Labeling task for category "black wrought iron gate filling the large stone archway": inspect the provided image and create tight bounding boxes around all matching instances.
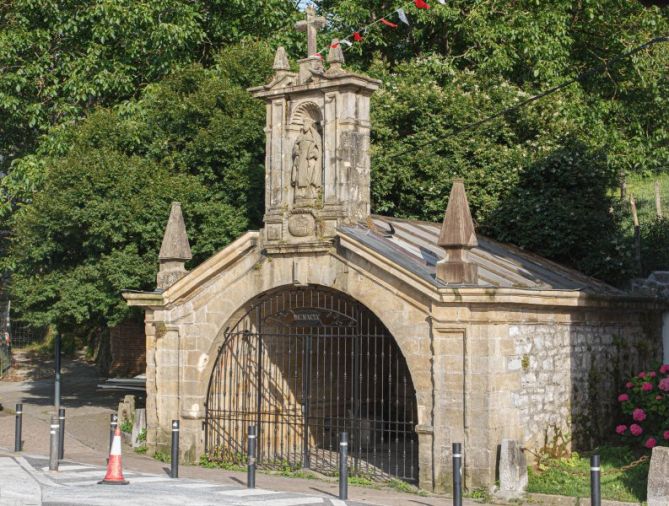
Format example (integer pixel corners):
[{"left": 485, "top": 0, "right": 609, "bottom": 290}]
[{"left": 205, "top": 288, "right": 418, "bottom": 482}]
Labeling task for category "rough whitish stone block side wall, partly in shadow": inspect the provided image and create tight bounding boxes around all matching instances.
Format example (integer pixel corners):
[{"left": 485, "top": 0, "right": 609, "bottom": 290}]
[{"left": 505, "top": 313, "right": 661, "bottom": 449}]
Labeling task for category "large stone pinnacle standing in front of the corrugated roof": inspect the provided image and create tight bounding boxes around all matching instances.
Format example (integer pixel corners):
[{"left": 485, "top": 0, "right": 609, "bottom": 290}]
[{"left": 437, "top": 178, "right": 478, "bottom": 284}]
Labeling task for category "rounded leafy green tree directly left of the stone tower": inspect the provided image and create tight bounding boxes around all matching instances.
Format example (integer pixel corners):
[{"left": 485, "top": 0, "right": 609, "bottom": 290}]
[{"left": 3, "top": 44, "right": 272, "bottom": 331}]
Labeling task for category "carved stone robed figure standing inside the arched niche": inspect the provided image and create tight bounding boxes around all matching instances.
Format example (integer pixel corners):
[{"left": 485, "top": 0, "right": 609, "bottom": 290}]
[{"left": 291, "top": 118, "right": 323, "bottom": 201}]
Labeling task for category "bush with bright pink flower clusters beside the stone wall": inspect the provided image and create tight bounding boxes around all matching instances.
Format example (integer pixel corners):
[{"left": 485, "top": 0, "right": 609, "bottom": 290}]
[{"left": 615, "top": 364, "right": 669, "bottom": 449}]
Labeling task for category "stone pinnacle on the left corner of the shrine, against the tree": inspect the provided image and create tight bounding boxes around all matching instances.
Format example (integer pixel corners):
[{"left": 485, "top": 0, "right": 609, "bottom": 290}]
[{"left": 157, "top": 202, "right": 193, "bottom": 290}]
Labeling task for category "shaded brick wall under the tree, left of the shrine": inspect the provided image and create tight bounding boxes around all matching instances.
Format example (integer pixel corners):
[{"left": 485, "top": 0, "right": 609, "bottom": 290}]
[{"left": 109, "top": 321, "right": 146, "bottom": 376}]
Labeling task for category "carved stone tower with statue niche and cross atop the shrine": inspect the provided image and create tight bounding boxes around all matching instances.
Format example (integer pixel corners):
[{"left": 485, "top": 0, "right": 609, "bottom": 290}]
[{"left": 249, "top": 6, "right": 380, "bottom": 252}]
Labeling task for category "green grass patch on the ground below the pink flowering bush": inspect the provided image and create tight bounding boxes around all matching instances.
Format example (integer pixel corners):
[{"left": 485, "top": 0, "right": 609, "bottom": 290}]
[{"left": 527, "top": 446, "right": 649, "bottom": 502}]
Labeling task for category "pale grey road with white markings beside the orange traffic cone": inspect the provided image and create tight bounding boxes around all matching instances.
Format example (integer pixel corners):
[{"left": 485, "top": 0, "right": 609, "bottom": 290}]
[{"left": 0, "top": 455, "right": 361, "bottom": 506}]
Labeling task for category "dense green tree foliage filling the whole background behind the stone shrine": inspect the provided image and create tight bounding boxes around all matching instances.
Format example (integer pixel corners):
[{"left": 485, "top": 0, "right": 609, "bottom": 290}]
[{"left": 0, "top": 0, "right": 669, "bottom": 327}]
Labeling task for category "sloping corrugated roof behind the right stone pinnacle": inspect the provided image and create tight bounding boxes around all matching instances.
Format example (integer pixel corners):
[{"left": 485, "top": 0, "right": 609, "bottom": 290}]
[{"left": 339, "top": 216, "right": 624, "bottom": 295}]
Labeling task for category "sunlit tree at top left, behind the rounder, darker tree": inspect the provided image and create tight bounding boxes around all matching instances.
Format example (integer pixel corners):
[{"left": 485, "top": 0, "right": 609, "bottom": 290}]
[{"left": 0, "top": 0, "right": 298, "bottom": 204}]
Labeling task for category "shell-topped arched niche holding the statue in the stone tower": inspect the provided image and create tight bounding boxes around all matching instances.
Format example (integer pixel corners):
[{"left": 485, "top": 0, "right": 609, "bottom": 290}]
[{"left": 290, "top": 102, "right": 324, "bottom": 207}]
